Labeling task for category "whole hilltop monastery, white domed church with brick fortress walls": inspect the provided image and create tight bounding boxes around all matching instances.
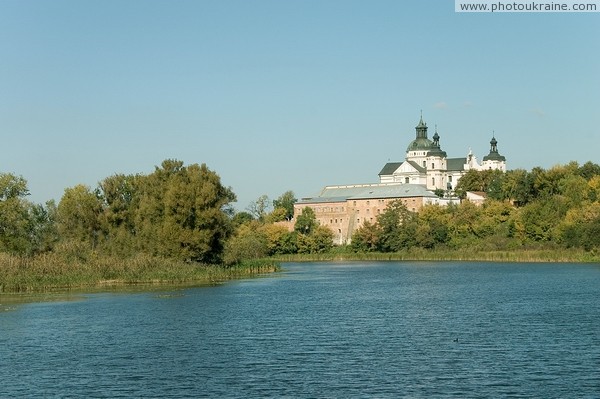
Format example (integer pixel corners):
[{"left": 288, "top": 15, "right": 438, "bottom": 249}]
[{"left": 294, "top": 112, "right": 506, "bottom": 244}]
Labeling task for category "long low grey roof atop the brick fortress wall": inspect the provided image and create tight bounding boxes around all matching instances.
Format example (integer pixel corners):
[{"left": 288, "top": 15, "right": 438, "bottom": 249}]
[{"left": 299, "top": 183, "right": 436, "bottom": 203}]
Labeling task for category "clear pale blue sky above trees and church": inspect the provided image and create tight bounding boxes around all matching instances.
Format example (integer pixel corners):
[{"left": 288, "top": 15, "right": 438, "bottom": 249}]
[{"left": 0, "top": 0, "right": 600, "bottom": 210}]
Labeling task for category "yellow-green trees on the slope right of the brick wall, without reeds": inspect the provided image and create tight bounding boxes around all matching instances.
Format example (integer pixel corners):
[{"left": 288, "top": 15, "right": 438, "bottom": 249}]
[{"left": 352, "top": 162, "right": 600, "bottom": 252}]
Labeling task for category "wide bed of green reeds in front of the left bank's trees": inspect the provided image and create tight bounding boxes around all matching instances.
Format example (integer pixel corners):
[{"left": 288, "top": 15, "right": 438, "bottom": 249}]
[{"left": 0, "top": 252, "right": 279, "bottom": 293}]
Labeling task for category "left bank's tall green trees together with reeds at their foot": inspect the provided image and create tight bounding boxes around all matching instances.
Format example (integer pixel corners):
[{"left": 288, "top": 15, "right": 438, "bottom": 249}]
[{"left": 0, "top": 160, "right": 277, "bottom": 292}]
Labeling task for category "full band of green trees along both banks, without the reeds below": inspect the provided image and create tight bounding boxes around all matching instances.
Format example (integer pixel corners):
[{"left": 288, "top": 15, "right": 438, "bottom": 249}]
[{"left": 0, "top": 160, "right": 600, "bottom": 265}]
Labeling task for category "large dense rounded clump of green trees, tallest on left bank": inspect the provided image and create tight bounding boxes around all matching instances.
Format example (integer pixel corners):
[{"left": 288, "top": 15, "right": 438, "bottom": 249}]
[{"left": 57, "top": 160, "right": 235, "bottom": 263}]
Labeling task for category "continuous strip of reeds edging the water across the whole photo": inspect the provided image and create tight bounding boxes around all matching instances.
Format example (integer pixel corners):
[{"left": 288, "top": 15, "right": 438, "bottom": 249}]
[{"left": 0, "top": 249, "right": 600, "bottom": 298}]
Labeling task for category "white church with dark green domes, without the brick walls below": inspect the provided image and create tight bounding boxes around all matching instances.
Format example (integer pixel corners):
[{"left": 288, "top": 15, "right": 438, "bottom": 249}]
[{"left": 379, "top": 115, "right": 506, "bottom": 190}]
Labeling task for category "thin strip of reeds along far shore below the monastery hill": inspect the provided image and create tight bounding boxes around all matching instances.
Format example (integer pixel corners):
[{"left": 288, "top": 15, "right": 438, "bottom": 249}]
[{"left": 273, "top": 248, "right": 600, "bottom": 262}]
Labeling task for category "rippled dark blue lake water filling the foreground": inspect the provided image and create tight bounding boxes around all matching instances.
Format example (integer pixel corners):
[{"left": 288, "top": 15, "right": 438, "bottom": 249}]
[{"left": 0, "top": 262, "right": 600, "bottom": 398}]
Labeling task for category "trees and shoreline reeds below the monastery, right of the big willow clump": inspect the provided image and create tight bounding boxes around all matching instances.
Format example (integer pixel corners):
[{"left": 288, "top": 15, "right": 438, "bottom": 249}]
[{"left": 230, "top": 162, "right": 600, "bottom": 262}]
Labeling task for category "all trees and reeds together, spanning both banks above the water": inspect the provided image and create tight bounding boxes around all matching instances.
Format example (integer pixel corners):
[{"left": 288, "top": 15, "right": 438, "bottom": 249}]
[{"left": 0, "top": 160, "right": 600, "bottom": 292}]
